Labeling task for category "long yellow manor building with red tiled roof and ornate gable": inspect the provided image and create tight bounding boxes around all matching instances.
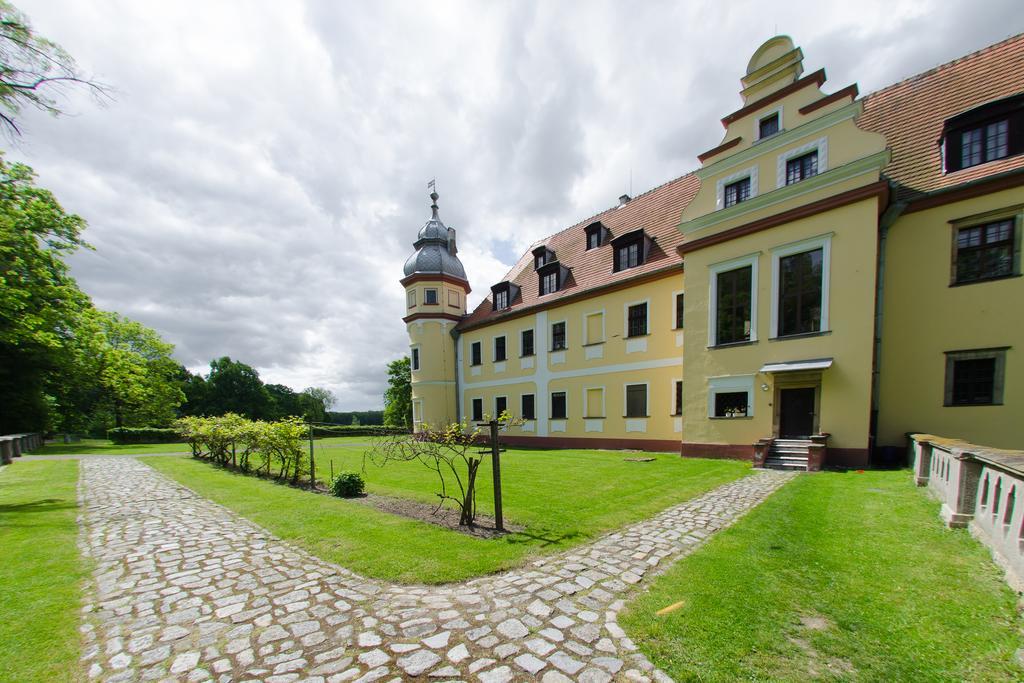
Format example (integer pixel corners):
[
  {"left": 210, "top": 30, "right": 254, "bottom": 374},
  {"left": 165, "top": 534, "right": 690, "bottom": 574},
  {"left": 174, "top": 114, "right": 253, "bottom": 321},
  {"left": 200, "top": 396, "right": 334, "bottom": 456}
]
[{"left": 402, "top": 36, "right": 1024, "bottom": 469}]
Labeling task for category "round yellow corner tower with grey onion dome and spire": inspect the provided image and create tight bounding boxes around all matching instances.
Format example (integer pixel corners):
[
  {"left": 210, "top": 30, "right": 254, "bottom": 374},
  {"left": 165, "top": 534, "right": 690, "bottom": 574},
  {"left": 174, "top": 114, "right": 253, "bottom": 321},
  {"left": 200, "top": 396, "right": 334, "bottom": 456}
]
[{"left": 401, "top": 191, "right": 470, "bottom": 431}]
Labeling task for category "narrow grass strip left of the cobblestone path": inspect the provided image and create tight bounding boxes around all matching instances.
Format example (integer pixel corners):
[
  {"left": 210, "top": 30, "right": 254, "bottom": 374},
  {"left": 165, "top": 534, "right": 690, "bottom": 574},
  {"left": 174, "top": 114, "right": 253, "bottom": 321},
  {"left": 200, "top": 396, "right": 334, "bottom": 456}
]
[{"left": 0, "top": 461, "right": 87, "bottom": 681}]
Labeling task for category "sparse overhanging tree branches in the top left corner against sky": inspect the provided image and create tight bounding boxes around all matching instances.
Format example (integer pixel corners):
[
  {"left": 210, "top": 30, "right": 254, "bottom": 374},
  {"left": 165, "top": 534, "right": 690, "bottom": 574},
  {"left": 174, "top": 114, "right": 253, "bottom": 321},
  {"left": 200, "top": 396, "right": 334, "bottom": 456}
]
[{"left": 0, "top": 0, "right": 110, "bottom": 136}]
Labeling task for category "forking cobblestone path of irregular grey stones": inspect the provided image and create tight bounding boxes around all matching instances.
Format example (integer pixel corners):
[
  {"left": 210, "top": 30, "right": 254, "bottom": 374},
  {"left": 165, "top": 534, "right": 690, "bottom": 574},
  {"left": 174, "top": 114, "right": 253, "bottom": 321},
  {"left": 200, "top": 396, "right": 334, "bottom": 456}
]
[{"left": 79, "top": 458, "right": 794, "bottom": 683}]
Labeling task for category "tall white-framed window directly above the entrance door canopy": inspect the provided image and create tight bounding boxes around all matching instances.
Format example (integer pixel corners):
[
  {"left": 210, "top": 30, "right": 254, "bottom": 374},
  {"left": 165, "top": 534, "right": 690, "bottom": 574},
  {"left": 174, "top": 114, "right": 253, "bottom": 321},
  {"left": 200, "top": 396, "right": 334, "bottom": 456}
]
[{"left": 778, "top": 249, "right": 823, "bottom": 337}]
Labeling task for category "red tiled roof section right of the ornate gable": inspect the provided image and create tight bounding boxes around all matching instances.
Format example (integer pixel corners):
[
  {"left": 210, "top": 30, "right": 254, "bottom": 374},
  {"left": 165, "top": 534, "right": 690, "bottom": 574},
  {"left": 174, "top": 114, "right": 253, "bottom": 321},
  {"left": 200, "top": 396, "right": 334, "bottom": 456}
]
[{"left": 857, "top": 34, "right": 1024, "bottom": 200}]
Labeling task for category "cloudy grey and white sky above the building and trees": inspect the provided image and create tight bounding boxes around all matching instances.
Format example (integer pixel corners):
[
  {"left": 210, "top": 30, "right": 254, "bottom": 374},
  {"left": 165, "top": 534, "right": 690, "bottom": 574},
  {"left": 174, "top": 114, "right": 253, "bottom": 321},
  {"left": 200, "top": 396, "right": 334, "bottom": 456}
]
[{"left": 6, "top": 0, "right": 1024, "bottom": 410}]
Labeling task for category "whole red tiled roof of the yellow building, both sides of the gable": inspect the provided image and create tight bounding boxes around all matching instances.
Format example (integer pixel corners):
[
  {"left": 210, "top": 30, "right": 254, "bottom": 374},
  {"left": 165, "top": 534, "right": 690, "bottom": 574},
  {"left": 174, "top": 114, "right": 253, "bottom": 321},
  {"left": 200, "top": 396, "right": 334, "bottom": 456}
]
[{"left": 458, "top": 34, "right": 1024, "bottom": 330}]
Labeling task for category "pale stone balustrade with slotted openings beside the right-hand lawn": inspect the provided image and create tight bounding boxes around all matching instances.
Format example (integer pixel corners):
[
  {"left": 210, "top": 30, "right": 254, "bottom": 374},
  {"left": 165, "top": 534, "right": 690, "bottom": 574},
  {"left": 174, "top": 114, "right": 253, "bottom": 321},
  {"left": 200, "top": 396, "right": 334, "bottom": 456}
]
[{"left": 909, "top": 434, "right": 1024, "bottom": 592}]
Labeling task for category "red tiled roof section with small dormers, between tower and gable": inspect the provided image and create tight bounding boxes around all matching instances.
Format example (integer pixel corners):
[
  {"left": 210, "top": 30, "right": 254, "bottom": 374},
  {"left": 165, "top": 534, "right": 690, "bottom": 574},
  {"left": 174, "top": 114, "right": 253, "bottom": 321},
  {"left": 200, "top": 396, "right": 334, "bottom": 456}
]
[{"left": 459, "top": 173, "right": 700, "bottom": 330}]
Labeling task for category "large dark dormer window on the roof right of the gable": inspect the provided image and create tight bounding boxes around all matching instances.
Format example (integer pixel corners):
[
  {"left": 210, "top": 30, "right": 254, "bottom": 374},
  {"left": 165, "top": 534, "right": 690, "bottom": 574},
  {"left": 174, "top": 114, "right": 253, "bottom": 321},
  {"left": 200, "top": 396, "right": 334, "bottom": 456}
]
[{"left": 942, "top": 94, "right": 1024, "bottom": 173}]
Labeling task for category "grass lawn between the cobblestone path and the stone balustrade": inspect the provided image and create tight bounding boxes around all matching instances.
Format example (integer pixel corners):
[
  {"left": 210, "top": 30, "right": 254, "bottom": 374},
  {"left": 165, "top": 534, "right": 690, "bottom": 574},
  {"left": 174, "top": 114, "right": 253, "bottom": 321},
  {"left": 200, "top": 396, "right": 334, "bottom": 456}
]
[{"left": 621, "top": 471, "right": 1024, "bottom": 681}]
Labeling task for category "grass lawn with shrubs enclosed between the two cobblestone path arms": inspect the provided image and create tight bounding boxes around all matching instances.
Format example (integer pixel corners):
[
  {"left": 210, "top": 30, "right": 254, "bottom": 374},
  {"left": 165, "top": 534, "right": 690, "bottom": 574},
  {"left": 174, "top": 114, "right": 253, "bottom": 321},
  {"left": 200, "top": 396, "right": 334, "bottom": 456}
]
[{"left": 144, "top": 446, "right": 750, "bottom": 584}]
